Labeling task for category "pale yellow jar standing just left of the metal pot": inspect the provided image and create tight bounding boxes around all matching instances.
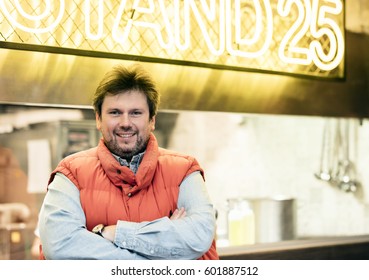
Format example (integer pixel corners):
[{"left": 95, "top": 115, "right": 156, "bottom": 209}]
[{"left": 227, "top": 198, "right": 255, "bottom": 246}]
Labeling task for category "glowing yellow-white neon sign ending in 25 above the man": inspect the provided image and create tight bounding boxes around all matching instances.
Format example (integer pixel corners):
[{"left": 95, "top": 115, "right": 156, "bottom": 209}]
[{"left": 0, "top": 0, "right": 345, "bottom": 78}]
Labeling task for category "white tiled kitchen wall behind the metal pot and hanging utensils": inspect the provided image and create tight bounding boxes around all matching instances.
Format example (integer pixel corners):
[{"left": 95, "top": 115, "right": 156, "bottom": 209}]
[{"left": 165, "top": 112, "right": 369, "bottom": 236}]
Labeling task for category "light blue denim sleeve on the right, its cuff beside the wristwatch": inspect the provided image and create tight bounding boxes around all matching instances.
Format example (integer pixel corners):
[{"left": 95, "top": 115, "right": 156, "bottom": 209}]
[{"left": 114, "top": 172, "right": 215, "bottom": 259}]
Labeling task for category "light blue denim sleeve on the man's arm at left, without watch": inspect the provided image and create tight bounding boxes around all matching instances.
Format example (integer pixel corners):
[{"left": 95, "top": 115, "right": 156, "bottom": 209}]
[{"left": 38, "top": 173, "right": 147, "bottom": 260}]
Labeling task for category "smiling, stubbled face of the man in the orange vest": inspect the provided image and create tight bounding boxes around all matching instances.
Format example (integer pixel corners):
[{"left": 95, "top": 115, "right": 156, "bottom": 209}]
[{"left": 96, "top": 90, "right": 155, "bottom": 159}]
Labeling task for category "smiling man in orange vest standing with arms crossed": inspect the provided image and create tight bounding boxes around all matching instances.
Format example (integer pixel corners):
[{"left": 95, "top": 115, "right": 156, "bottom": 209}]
[{"left": 39, "top": 66, "right": 218, "bottom": 259}]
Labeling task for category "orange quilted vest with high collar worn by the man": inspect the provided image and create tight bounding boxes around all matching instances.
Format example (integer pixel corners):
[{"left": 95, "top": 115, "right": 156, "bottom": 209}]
[{"left": 50, "top": 134, "right": 219, "bottom": 259}]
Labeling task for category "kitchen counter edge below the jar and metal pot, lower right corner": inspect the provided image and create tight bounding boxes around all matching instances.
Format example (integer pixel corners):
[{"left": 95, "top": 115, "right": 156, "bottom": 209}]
[{"left": 218, "top": 235, "right": 369, "bottom": 260}]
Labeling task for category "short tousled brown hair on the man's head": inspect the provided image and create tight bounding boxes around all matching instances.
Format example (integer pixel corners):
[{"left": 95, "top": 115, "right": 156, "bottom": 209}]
[{"left": 93, "top": 64, "right": 160, "bottom": 119}]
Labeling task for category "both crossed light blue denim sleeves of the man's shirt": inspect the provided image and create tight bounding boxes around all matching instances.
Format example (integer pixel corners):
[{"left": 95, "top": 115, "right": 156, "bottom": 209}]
[{"left": 39, "top": 172, "right": 215, "bottom": 260}]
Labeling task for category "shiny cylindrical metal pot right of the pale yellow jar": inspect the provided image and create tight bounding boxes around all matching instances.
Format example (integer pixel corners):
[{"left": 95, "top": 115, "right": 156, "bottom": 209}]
[{"left": 251, "top": 197, "right": 296, "bottom": 243}]
